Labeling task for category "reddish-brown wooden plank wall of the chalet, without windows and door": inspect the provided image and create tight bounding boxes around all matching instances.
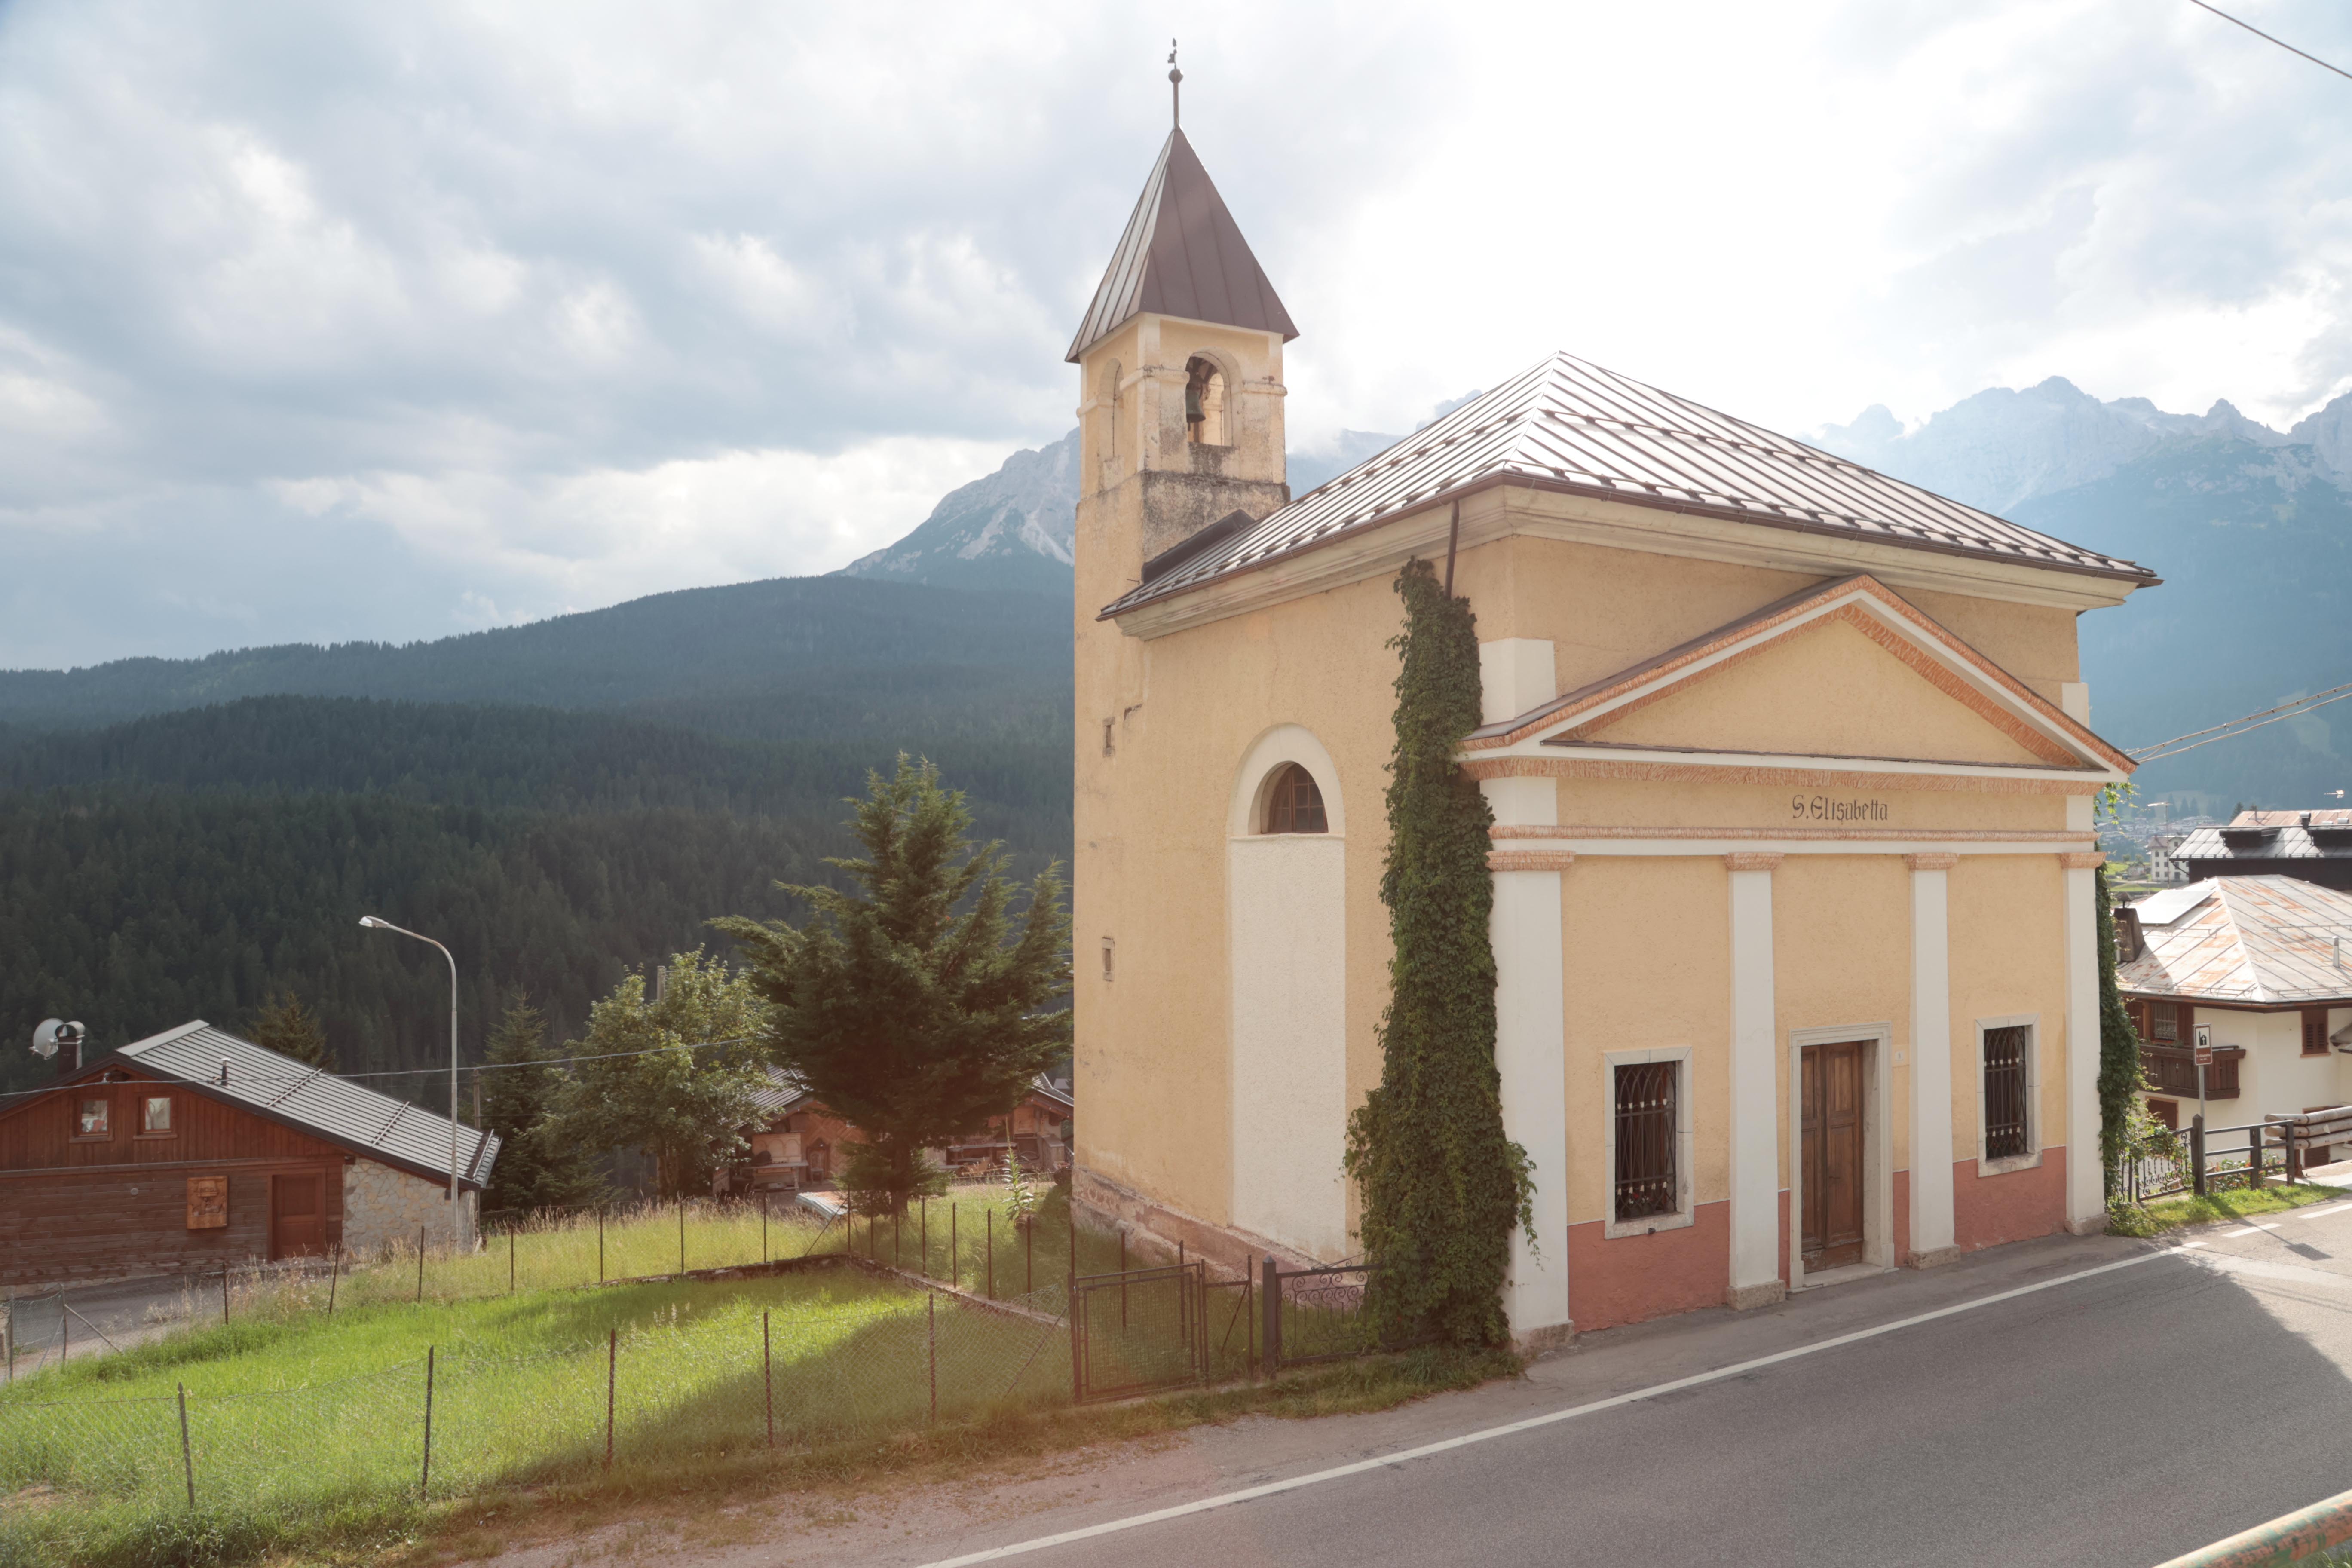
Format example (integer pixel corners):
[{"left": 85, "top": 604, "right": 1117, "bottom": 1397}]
[{"left": 0, "top": 1077, "right": 346, "bottom": 1283}]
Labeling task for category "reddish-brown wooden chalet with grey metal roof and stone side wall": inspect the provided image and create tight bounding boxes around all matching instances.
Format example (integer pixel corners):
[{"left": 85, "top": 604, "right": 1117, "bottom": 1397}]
[{"left": 0, "top": 1020, "right": 499, "bottom": 1283}]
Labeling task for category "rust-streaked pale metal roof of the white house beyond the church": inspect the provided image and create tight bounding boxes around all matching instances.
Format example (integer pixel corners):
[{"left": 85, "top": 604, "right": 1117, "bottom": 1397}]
[{"left": 2114, "top": 877, "right": 2352, "bottom": 1006}]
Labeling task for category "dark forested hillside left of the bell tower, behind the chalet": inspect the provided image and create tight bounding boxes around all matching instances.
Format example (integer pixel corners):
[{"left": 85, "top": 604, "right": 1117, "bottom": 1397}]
[{"left": 0, "top": 578, "right": 1070, "bottom": 1098}]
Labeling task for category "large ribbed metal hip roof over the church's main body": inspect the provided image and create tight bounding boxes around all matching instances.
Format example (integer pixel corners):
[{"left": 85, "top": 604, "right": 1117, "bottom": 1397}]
[{"left": 1103, "top": 352, "right": 2157, "bottom": 616}]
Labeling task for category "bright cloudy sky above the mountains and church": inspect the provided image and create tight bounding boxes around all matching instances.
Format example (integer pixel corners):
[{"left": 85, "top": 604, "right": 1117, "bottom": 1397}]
[{"left": 0, "top": 0, "right": 2352, "bottom": 665}]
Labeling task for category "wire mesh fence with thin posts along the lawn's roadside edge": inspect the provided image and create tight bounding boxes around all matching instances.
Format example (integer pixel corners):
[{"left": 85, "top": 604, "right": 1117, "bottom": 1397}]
[{"left": 0, "top": 1286, "right": 1070, "bottom": 1528}]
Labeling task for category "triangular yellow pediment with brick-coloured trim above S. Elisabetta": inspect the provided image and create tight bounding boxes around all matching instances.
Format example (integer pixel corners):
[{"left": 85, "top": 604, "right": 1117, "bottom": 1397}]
[{"left": 1465, "top": 576, "right": 2133, "bottom": 778}]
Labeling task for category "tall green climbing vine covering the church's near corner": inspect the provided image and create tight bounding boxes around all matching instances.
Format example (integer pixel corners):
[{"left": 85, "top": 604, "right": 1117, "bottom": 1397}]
[{"left": 1348, "top": 560, "right": 1534, "bottom": 1344}]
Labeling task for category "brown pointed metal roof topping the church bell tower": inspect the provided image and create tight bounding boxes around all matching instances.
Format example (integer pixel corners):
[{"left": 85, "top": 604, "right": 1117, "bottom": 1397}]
[{"left": 1068, "top": 129, "right": 1298, "bottom": 364}]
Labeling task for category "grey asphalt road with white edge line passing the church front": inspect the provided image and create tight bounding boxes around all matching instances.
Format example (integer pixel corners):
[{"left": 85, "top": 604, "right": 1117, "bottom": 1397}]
[{"left": 868, "top": 1204, "right": 2352, "bottom": 1568}]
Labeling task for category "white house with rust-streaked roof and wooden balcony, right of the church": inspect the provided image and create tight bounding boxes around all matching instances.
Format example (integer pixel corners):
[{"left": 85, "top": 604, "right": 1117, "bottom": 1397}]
[{"left": 2114, "top": 875, "right": 2352, "bottom": 1159}]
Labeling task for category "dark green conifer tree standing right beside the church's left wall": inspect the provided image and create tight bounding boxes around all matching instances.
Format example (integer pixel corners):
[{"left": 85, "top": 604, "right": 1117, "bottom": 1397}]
[{"left": 713, "top": 755, "right": 1070, "bottom": 1211}]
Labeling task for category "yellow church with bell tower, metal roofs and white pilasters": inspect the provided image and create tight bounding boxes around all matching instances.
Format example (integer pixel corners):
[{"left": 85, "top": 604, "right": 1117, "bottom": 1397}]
[{"left": 1068, "top": 129, "right": 2157, "bottom": 1344}]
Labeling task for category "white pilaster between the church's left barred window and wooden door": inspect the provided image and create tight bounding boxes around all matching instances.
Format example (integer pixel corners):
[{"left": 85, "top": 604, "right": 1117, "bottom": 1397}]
[{"left": 1724, "top": 853, "right": 1785, "bottom": 1307}]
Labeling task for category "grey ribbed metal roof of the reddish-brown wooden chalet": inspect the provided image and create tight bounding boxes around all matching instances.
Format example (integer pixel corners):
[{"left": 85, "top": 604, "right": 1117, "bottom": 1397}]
[{"left": 103, "top": 1018, "right": 499, "bottom": 1187}]
